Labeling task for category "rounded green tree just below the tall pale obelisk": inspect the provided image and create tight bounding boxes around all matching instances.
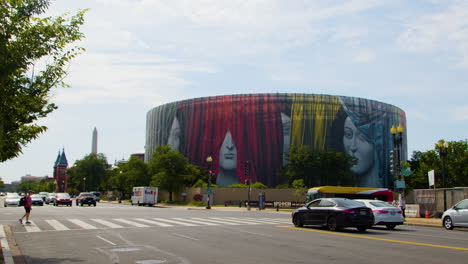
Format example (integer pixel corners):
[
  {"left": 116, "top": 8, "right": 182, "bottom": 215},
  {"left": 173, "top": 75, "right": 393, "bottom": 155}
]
[{"left": 67, "top": 153, "right": 109, "bottom": 193}]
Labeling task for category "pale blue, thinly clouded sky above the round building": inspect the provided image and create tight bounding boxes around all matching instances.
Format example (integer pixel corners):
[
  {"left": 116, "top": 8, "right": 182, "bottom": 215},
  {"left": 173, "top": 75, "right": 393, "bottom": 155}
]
[{"left": 0, "top": 0, "right": 468, "bottom": 183}]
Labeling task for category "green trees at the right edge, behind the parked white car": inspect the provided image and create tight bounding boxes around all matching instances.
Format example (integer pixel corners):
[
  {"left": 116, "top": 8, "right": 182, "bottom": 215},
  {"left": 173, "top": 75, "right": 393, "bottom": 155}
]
[{"left": 405, "top": 140, "right": 468, "bottom": 191}]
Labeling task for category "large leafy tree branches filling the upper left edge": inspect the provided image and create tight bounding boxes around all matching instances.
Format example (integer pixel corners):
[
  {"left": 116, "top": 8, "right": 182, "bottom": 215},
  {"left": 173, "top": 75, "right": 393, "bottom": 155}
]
[{"left": 0, "top": 0, "right": 86, "bottom": 162}]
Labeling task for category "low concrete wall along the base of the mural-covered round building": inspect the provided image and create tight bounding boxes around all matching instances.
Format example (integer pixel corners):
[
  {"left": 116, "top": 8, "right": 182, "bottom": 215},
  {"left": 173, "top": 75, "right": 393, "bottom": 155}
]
[{"left": 158, "top": 188, "right": 307, "bottom": 205}]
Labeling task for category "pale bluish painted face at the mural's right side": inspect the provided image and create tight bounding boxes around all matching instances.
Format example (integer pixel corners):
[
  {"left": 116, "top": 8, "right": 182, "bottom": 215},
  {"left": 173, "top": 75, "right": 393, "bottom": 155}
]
[{"left": 343, "top": 117, "right": 374, "bottom": 174}]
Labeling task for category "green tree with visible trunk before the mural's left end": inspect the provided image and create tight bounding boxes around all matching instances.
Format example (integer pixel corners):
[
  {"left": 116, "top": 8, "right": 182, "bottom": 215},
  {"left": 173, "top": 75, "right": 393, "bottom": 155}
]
[{"left": 149, "top": 145, "right": 188, "bottom": 201}]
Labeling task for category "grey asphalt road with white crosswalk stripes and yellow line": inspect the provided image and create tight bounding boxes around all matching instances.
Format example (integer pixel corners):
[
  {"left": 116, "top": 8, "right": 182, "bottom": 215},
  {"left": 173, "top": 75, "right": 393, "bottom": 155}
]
[{"left": 0, "top": 203, "right": 468, "bottom": 264}]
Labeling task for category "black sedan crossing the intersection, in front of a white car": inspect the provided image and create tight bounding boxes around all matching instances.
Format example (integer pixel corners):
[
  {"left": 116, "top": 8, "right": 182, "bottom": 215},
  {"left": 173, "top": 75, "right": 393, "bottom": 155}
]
[{"left": 292, "top": 198, "right": 374, "bottom": 232}]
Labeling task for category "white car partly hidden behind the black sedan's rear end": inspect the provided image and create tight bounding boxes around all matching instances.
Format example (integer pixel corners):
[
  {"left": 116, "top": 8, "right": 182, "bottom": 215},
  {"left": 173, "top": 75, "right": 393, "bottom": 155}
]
[{"left": 356, "top": 200, "right": 405, "bottom": 230}]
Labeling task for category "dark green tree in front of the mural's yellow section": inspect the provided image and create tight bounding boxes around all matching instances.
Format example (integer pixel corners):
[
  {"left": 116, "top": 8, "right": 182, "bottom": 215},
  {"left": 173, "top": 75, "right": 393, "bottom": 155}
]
[{"left": 283, "top": 146, "right": 356, "bottom": 187}]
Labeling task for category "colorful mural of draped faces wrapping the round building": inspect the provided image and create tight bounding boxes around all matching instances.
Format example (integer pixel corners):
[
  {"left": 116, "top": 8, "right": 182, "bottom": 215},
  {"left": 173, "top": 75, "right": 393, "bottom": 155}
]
[{"left": 145, "top": 94, "right": 406, "bottom": 188}]
